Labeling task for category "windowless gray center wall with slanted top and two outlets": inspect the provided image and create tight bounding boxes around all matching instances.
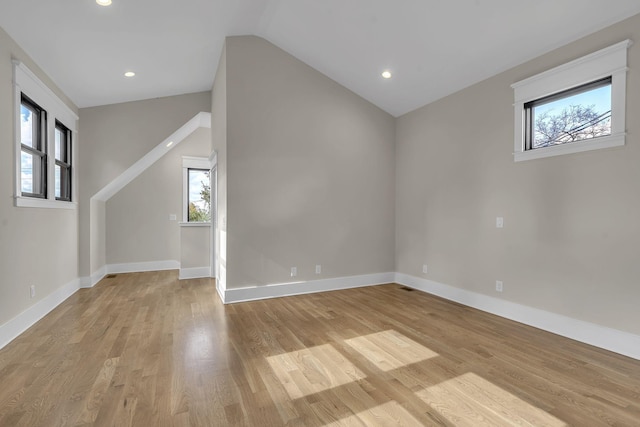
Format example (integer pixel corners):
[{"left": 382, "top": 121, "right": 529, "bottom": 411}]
[{"left": 226, "top": 36, "right": 395, "bottom": 288}]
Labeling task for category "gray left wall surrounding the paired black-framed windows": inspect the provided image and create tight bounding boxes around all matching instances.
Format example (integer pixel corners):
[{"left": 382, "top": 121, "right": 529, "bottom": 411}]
[{"left": 0, "top": 28, "right": 78, "bottom": 325}]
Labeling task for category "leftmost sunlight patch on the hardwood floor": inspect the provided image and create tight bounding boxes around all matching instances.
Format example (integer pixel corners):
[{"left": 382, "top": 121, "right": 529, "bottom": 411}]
[{"left": 267, "top": 344, "right": 365, "bottom": 399}]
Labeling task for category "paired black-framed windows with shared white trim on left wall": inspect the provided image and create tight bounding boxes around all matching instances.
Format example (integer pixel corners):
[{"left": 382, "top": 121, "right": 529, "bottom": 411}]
[{"left": 13, "top": 60, "right": 78, "bottom": 209}]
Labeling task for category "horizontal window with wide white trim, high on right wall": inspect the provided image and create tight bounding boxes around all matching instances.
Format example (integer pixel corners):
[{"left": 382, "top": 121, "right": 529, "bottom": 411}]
[{"left": 512, "top": 40, "right": 630, "bottom": 161}]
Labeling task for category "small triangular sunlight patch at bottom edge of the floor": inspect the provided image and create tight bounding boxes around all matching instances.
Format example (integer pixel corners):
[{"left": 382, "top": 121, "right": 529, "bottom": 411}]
[{"left": 325, "top": 400, "right": 423, "bottom": 427}]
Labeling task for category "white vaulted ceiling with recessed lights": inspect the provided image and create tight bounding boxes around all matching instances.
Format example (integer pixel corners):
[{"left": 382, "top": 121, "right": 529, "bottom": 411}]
[{"left": 0, "top": 0, "right": 640, "bottom": 116}]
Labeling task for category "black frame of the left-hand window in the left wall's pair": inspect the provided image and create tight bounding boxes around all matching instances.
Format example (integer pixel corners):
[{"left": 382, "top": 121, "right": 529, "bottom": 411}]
[{"left": 20, "top": 93, "right": 48, "bottom": 199}]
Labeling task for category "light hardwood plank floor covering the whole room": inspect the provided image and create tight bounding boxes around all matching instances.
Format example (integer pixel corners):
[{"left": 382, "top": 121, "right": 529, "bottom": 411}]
[{"left": 0, "top": 271, "right": 640, "bottom": 427}]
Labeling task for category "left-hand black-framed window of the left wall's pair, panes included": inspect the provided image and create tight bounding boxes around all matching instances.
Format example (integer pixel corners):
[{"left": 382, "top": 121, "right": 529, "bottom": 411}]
[{"left": 20, "top": 95, "right": 47, "bottom": 198}]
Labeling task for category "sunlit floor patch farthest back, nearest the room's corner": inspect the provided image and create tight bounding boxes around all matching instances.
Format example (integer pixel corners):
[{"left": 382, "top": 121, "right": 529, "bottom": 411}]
[{"left": 345, "top": 330, "right": 438, "bottom": 371}]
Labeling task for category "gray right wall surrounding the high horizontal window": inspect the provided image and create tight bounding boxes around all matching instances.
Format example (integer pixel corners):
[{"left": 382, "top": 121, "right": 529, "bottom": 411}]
[{"left": 396, "top": 15, "right": 640, "bottom": 334}]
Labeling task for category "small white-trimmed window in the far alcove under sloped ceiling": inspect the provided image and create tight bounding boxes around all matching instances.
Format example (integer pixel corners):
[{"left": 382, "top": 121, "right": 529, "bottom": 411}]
[{"left": 182, "top": 156, "right": 211, "bottom": 225}]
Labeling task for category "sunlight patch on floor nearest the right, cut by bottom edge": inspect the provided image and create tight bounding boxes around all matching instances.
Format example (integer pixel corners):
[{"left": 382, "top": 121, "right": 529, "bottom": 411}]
[{"left": 416, "top": 372, "right": 566, "bottom": 427}]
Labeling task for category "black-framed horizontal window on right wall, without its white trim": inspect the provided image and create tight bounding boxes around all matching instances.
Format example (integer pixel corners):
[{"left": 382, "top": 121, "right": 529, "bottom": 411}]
[{"left": 524, "top": 76, "right": 611, "bottom": 150}]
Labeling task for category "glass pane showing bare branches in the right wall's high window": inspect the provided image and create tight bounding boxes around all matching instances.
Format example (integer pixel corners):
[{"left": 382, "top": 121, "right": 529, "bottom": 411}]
[{"left": 531, "top": 83, "right": 611, "bottom": 148}]
